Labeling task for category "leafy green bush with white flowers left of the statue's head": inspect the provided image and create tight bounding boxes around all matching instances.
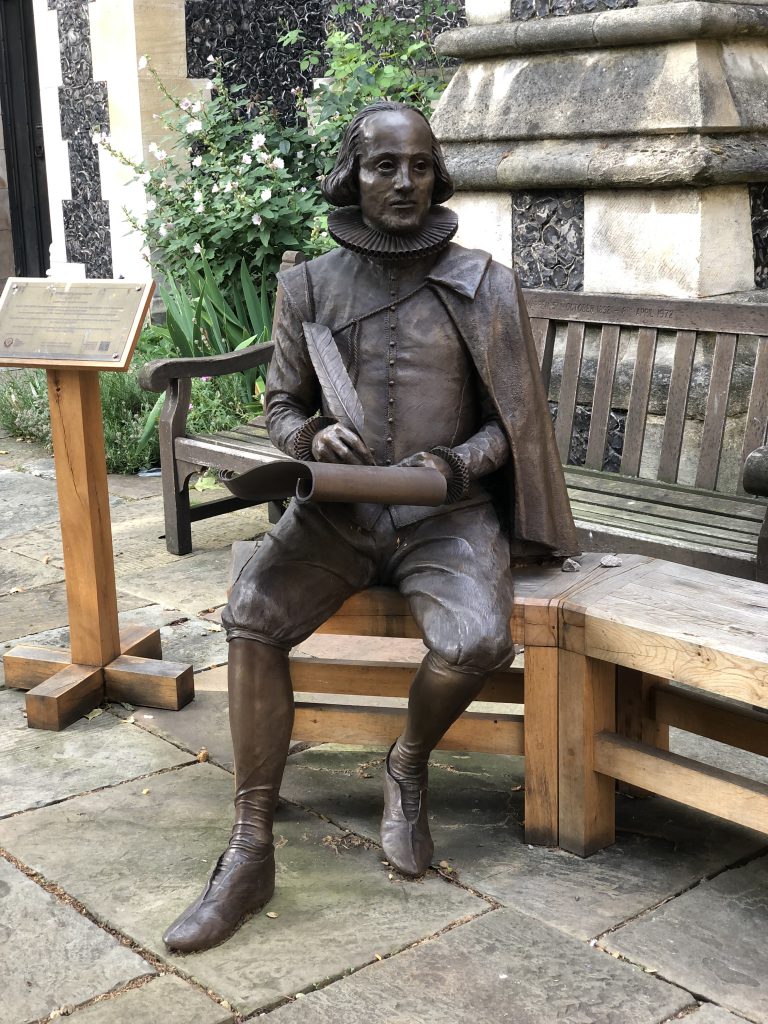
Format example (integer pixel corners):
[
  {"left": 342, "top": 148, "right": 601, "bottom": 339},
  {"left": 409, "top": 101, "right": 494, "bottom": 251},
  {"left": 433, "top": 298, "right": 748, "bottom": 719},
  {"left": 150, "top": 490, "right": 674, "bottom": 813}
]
[{"left": 94, "top": 57, "right": 327, "bottom": 285}]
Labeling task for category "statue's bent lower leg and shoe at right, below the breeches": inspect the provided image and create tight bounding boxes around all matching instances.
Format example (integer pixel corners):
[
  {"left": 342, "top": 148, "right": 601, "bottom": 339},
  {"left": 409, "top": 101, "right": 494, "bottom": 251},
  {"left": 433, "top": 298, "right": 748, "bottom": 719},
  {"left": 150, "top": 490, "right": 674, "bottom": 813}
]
[{"left": 381, "top": 651, "right": 487, "bottom": 878}]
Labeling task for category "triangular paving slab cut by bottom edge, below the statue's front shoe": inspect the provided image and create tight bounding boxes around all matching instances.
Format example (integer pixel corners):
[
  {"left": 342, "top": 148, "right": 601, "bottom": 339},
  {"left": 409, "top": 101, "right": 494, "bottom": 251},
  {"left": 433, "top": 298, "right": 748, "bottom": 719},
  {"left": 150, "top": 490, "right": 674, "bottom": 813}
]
[{"left": 62, "top": 974, "right": 233, "bottom": 1024}]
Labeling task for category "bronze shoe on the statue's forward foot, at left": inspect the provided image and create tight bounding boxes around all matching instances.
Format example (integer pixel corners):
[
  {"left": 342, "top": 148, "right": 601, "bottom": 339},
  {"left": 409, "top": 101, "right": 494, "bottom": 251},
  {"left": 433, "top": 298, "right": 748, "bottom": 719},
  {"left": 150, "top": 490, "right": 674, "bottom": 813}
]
[{"left": 163, "top": 847, "right": 274, "bottom": 953}]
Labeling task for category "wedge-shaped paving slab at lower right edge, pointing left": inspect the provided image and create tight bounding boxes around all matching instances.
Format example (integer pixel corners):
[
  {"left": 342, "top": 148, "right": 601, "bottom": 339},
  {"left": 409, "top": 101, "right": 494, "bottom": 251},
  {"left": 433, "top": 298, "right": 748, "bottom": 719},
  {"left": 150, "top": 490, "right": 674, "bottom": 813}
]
[{"left": 605, "top": 856, "right": 768, "bottom": 1024}]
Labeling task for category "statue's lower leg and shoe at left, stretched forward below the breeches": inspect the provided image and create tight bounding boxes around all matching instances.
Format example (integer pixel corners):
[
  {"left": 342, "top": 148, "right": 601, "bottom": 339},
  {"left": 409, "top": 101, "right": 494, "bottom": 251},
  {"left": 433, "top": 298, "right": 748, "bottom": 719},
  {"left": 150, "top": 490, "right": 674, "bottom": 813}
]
[{"left": 163, "top": 638, "right": 294, "bottom": 953}]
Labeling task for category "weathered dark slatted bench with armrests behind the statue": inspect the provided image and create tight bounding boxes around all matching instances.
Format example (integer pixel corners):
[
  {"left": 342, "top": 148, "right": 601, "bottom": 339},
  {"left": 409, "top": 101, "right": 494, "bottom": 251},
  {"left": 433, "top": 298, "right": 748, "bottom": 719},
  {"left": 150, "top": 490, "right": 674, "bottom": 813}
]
[{"left": 141, "top": 276, "right": 768, "bottom": 581}]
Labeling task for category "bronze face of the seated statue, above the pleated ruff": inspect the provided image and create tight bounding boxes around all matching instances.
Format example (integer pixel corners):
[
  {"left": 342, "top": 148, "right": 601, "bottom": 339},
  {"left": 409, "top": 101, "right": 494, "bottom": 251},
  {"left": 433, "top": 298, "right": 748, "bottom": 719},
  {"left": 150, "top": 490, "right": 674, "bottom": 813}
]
[{"left": 358, "top": 111, "right": 434, "bottom": 234}]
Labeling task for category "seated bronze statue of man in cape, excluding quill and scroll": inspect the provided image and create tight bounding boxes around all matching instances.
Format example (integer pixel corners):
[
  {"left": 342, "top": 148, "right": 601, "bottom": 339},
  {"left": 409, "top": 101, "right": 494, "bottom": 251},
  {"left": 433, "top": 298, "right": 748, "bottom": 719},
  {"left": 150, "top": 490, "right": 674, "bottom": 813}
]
[{"left": 164, "top": 101, "right": 578, "bottom": 952}]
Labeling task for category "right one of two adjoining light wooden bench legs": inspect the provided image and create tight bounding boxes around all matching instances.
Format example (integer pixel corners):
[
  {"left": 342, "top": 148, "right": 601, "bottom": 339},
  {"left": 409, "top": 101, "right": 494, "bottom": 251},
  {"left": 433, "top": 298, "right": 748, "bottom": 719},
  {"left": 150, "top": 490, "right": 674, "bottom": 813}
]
[{"left": 558, "top": 650, "right": 616, "bottom": 857}]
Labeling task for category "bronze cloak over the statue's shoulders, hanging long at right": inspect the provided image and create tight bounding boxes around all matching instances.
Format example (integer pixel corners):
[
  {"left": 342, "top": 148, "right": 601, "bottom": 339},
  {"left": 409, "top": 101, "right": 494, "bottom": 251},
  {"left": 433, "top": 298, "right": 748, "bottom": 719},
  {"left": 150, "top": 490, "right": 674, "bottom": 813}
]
[{"left": 281, "top": 244, "right": 580, "bottom": 559}]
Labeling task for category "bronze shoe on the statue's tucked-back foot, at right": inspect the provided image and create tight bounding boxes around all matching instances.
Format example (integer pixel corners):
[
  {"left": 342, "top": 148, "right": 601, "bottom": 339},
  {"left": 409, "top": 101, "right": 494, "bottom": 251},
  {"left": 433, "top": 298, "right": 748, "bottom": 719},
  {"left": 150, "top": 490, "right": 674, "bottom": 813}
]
[{"left": 381, "top": 748, "right": 434, "bottom": 878}]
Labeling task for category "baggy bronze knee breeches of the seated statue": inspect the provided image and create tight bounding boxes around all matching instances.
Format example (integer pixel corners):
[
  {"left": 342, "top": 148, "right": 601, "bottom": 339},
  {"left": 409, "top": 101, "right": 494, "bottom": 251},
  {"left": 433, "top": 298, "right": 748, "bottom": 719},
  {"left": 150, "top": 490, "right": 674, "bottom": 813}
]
[{"left": 221, "top": 502, "right": 513, "bottom": 673}]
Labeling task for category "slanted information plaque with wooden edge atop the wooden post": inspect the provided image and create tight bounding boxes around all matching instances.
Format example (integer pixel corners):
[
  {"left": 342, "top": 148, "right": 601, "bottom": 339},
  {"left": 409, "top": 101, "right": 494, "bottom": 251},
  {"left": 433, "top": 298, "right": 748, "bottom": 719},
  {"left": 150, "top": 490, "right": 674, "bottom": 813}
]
[{"left": 0, "top": 278, "right": 154, "bottom": 370}]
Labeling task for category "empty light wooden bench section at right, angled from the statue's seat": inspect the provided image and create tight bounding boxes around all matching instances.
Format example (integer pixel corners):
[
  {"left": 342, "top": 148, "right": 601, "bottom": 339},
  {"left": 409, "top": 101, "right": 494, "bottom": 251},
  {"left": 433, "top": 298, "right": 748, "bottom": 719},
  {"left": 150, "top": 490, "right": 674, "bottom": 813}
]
[{"left": 557, "top": 557, "right": 768, "bottom": 856}]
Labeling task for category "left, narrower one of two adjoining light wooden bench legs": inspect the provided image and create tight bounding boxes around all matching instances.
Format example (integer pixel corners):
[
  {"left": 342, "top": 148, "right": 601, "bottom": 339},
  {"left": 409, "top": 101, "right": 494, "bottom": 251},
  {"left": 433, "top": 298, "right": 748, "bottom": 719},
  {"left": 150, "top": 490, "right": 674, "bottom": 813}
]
[{"left": 523, "top": 647, "right": 558, "bottom": 846}]
